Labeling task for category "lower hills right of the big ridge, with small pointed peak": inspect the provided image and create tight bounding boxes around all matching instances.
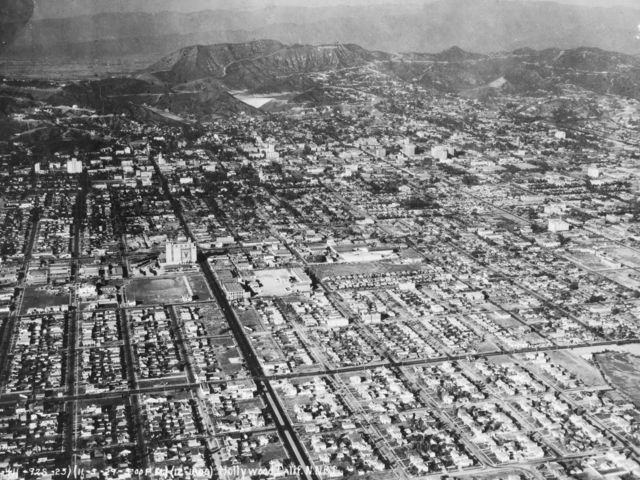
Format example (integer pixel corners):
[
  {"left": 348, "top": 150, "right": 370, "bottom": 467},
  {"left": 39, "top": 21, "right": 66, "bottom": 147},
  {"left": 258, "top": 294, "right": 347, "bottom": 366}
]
[{"left": 383, "top": 47, "right": 640, "bottom": 98}]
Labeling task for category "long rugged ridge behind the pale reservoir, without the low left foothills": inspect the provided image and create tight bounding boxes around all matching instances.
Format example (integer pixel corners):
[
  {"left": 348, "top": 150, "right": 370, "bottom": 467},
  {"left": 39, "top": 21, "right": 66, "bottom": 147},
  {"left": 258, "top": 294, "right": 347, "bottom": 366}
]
[{"left": 144, "top": 40, "right": 640, "bottom": 98}]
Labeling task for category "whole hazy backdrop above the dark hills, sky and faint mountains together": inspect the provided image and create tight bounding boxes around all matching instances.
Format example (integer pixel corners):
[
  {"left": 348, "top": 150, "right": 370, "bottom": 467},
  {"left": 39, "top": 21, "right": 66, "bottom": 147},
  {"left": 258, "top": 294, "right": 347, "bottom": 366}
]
[{"left": 0, "top": 0, "right": 640, "bottom": 79}]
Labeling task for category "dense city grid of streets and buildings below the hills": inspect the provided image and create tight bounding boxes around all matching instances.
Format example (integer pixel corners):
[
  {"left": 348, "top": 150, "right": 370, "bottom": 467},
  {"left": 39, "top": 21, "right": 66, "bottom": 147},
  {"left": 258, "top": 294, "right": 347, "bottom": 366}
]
[{"left": 0, "top": 42, "right": 640, "bottom": 480}]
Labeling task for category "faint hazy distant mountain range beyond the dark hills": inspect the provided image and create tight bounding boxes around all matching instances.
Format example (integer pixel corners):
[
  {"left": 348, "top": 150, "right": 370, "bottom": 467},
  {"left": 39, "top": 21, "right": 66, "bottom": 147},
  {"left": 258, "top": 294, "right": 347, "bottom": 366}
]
[{"left": 3, "top": 0, "right": 640, "bottom": 67}]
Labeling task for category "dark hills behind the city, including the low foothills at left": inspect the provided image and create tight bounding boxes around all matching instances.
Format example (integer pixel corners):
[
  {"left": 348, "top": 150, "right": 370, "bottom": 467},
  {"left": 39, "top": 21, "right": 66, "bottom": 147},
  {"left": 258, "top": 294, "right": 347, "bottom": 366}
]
[{"left": 6, "top": 40, "right": 640, "bottom": 121}]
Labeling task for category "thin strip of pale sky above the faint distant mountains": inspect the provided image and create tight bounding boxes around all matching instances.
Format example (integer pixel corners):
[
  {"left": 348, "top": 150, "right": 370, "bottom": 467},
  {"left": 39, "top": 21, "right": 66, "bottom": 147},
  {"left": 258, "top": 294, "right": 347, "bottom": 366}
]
[{"left": 35, "top": 0, "right": 640, "bottom": 18}]
